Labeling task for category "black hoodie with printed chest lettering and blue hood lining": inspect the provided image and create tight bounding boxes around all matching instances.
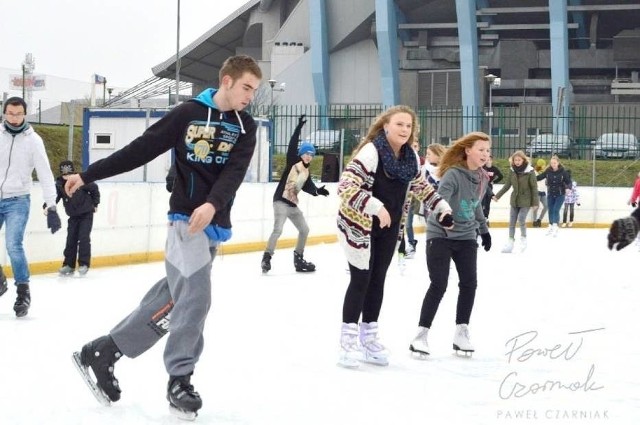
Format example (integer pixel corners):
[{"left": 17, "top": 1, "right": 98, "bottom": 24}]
[{"left": 80, "top": 89, "right": 256, "bottom": 228}]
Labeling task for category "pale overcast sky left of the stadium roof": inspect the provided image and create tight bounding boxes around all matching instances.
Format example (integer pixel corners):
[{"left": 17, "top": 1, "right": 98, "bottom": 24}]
[{"left": 0, "top": 0, "right": 247, "bottom": 87}]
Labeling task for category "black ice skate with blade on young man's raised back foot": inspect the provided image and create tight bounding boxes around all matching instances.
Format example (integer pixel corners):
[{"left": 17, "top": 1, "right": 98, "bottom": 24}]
[{"left": 73, "top": 335, "right": 122, "bottom": 406}]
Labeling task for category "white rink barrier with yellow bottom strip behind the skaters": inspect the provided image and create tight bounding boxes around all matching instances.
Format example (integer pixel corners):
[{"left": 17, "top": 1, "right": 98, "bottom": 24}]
[{"left": 0, "top": 182, "right": 631, "bottom": 276}]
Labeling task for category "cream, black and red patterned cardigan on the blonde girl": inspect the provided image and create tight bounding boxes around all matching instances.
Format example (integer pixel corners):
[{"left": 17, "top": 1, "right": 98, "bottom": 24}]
[{"left": 337, "top": 143, "right": 451, "bottom": 270}]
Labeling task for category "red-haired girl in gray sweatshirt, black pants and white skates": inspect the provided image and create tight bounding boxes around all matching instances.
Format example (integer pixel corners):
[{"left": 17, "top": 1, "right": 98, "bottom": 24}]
[{"left": 409, "top": 132, "right": 491, "bottom": 355}]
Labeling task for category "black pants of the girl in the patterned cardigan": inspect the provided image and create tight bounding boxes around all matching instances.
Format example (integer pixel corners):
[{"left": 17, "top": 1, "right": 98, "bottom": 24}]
[{"left": 342, "top": 220, "right": 399, "bottom": 323}]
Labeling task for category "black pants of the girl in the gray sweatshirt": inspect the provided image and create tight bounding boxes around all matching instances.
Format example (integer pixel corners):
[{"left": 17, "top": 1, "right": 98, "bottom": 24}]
[{"left": 419, "top": 238, "right": 478, "bottom": 328}]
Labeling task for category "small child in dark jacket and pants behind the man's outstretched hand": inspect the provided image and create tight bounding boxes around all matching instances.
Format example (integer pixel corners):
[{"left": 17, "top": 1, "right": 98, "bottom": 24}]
[{"left": 56, "top": 161, "right": 100, "bottom": 276}]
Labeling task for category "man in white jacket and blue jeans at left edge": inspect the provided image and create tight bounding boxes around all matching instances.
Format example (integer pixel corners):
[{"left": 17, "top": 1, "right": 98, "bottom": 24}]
[{"left": 0, "top": 97, "right": 60, "bottom": 317}]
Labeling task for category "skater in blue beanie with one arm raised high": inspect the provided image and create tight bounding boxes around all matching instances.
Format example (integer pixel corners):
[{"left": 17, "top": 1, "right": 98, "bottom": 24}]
[{"left": 261, "top": 115, "right": 329, "bottom": 273}]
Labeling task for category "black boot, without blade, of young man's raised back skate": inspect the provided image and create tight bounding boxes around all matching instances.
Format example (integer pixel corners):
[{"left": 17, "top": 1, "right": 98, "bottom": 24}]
[{"left": 80, "top": 335, "right": 122, "bottom": 401}]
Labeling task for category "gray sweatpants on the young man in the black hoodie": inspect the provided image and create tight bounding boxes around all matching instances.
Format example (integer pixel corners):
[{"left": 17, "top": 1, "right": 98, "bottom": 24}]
[{"left": 110, "top": 221, "right": 218, "bottom": 376}]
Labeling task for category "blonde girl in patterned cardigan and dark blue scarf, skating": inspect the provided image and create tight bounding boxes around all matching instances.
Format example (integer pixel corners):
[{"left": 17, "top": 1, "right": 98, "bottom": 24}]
[{"left": 337, "top": 105, "right": 453, "bottom": 368}]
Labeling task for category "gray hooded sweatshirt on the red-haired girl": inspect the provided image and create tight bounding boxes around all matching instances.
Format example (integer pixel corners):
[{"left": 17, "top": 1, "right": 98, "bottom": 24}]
[{"left": 427, "top": 166, "right": 489, "bottom": 240}]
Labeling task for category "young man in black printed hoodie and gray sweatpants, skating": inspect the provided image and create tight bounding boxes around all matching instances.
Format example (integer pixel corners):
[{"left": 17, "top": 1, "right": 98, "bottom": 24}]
[{"left": 65, "top": 55, "right": 262, "bottom": 419}]
